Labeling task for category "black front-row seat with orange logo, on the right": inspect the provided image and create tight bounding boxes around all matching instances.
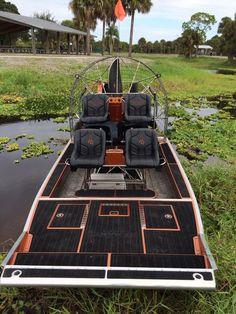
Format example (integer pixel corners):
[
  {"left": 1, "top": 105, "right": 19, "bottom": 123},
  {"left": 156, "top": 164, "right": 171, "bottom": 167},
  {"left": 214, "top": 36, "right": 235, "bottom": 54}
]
[{"left": 125, "top": 128, "right": 160, "bottom": 168}]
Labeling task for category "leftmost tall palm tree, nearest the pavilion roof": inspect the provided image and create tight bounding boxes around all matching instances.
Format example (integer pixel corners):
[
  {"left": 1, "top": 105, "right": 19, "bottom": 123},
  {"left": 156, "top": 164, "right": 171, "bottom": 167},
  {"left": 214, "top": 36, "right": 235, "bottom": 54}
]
[{"left": 69, "top": 0, "right": 97, "bottom": 55}]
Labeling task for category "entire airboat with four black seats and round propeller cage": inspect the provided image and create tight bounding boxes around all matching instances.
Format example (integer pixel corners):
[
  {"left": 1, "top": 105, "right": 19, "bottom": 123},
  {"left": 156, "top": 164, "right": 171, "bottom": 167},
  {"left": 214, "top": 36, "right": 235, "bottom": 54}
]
[{"left": 0, "top": 57, "right": 216, "bottom": 289}]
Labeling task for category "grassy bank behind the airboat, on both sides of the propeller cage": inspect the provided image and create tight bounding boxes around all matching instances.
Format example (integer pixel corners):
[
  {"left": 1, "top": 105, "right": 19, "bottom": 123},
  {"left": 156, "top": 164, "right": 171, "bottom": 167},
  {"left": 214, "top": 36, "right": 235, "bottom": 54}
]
[{"left": 0, "top": 54, "right": 236, "bottom": 118}]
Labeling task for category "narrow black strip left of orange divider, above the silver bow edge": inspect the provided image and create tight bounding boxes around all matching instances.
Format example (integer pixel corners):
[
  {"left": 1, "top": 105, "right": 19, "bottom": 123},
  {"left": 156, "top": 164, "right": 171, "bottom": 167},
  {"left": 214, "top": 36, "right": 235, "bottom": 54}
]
[{"left": 15, "top": 253, "right": 107, "bottom": 266}]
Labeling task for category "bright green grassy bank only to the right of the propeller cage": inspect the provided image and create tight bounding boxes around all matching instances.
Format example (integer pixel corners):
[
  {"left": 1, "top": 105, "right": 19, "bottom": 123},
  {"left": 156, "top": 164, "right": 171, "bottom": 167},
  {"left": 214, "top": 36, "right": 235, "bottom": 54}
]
[{"left": 137, "top": 55, "right": 236, "bottom": 99}]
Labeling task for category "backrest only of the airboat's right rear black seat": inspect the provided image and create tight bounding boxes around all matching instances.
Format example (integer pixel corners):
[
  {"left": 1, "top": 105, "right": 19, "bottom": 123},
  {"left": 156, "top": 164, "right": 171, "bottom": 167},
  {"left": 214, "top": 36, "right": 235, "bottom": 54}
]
[{"left": 125, "top": 94, "right": 151, "bottom": 117}]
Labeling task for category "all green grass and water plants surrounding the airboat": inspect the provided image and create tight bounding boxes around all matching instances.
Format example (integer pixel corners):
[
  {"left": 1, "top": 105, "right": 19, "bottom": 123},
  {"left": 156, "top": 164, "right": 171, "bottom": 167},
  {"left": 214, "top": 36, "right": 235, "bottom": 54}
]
[{"left": 0, "top": 55, "right": 236, "bottom": 314}]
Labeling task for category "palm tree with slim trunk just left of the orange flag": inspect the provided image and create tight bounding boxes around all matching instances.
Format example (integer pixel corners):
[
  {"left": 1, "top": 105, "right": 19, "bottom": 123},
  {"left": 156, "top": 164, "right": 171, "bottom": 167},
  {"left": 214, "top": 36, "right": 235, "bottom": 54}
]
[{"left": 95, "top": 0, "right": 116, "bottom": 55}]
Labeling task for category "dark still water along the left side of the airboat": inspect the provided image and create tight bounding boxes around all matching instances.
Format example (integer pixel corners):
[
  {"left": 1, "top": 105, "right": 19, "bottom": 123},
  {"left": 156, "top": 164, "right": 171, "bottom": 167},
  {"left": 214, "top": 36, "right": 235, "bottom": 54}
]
[{"left": 0, "top": 121, "right": 69, "bottom": 249}]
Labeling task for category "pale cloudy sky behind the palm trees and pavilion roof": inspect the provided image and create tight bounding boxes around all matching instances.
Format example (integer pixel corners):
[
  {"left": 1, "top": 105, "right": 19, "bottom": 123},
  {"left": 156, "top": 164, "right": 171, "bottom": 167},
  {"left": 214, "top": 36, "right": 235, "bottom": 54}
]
[{"left": 10, "top": 0, "right": 236, "bottom": 43}]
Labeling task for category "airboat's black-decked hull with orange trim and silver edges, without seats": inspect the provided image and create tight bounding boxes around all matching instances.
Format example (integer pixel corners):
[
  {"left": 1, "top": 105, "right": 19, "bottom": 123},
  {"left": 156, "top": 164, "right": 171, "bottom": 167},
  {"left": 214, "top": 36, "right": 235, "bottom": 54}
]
[{"left": 0, "top": 138, "right": 216, "bottom": 289}]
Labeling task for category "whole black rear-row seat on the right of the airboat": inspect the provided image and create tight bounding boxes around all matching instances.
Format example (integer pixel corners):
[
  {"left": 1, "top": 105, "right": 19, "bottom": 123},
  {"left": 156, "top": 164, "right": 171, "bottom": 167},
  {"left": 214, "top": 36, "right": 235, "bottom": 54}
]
[{"left": 125, "top": 94, "right": 152, "bottom": 123}]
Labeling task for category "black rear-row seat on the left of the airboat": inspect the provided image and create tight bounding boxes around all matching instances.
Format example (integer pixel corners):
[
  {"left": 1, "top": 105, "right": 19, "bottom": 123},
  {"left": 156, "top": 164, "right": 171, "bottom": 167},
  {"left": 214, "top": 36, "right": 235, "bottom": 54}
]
[{"left": 80, "top": 94, "right": 108, "bottom": 123}]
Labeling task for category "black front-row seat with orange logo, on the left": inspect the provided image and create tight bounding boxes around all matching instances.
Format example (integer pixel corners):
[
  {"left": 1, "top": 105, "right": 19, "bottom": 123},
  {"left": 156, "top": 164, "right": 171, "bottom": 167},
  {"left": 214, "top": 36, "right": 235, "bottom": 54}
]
[{"left": 70, "top": 129, "right": 106, "bottom": 171}]
